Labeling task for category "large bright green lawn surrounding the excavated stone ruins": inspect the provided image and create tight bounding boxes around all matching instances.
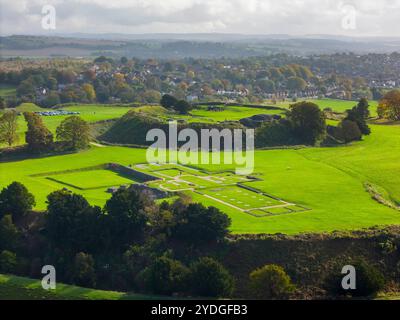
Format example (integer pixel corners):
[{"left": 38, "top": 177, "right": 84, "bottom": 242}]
[{"left": 0, "top": 120, "right": 400, "bottom": 234}]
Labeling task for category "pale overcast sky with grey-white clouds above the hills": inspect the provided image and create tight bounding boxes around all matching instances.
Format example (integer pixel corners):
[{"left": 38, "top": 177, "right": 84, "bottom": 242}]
[{"left": 0, "top": 0, "right": 400, "bottom": 36}]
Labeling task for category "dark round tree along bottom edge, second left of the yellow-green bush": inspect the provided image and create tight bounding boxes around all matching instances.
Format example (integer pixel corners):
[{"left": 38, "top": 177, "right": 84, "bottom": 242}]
[{"left": 141, "top": 256, "right": 189, "bottom": 295}]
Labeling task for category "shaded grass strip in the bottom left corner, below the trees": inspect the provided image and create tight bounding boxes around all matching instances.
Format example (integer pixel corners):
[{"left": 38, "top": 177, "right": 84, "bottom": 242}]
[{"left": 0, "top": 274, "right": 166, "bottom": 300}]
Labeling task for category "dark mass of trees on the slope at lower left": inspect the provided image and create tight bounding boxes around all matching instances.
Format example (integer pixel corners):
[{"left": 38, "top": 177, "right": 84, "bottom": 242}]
[{"left": 0, "top": 182, "right": 234, "bottom": 296}]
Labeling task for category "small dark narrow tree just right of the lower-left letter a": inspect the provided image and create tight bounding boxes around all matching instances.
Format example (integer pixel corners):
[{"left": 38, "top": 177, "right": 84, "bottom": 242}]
[{"left": 72, "top": 252, "right": 96, "bottom": 288}]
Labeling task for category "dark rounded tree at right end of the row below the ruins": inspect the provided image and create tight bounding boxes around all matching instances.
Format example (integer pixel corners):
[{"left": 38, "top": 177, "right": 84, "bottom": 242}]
[{"left": 172, "top": 203, "right": 231, "bottom": 244}]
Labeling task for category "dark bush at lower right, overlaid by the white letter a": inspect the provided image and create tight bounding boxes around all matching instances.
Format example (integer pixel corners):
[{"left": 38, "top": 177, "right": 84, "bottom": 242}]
[{"left": 325, "top": 260, "right": 385, "bottom": 297}]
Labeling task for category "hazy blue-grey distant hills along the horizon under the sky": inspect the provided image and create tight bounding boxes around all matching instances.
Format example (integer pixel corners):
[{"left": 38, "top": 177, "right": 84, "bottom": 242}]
[{"left": 0, "top": 34, "right": 400, "bottom": 59}]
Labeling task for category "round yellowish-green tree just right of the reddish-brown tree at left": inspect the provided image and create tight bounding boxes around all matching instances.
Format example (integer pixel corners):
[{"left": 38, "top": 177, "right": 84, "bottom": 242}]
[{"left": 56, "top": 116, "right": 89, "bottom": 150}]
